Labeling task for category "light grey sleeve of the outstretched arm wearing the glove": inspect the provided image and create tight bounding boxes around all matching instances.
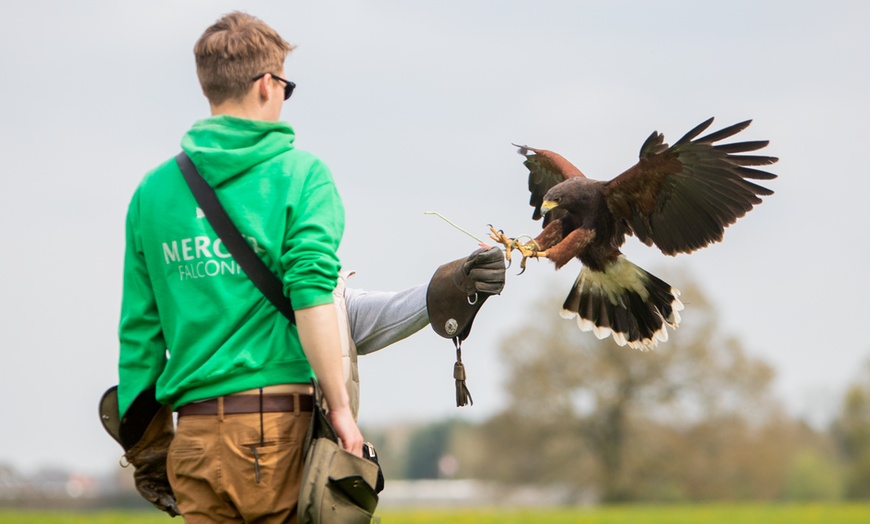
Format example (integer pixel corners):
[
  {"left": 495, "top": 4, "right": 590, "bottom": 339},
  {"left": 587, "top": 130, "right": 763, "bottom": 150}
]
[{"left": 344, "top": 284, "right": 429, "bottom": 355}]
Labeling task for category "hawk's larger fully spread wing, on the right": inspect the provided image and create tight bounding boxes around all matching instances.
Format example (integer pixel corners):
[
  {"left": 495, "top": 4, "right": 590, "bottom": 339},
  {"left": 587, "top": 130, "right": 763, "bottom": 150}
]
[{"left": 605, "top": 118, "right": 778, "bottom": 255}]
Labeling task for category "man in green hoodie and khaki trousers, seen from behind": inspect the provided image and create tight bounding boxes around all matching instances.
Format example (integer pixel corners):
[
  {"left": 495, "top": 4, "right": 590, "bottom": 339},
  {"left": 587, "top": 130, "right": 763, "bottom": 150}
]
[{"left": 118, "top": 12, "right": 363, "bottom": 522}]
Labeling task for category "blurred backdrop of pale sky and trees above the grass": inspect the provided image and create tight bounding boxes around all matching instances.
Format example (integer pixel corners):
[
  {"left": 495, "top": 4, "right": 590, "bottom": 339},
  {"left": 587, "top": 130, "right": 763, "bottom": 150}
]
[{"left": 0, "top": 0, "right": 870, "bottom": 504}]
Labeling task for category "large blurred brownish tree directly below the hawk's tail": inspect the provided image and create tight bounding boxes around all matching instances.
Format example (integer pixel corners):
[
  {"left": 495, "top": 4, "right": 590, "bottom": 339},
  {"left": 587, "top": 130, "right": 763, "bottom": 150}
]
[{"left": 475, "top": 276, "right": 791, "bottom": 501}]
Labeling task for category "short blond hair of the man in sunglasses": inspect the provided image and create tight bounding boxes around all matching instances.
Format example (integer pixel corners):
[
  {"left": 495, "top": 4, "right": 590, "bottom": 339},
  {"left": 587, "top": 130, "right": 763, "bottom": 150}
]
[{"left": 193, "top": 11, "right": 293, "bottom": 105}]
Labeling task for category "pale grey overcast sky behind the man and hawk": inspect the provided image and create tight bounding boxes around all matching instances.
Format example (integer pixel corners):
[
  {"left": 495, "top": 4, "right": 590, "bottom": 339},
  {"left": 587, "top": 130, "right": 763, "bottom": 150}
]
[{"left": 0, "top": 0, "right": 870, "bottom": 472}]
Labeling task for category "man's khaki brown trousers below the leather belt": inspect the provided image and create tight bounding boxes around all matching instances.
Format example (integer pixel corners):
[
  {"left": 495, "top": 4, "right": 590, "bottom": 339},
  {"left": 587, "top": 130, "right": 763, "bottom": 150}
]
[{"left": 167, "top": 412, "right": 311, "bottom": 524}]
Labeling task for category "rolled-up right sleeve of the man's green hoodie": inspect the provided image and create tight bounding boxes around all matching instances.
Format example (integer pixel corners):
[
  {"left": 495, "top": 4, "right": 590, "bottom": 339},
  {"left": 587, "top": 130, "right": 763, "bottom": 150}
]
[{"left": 281, "top": 160, "right": 344, "bottom": 309}]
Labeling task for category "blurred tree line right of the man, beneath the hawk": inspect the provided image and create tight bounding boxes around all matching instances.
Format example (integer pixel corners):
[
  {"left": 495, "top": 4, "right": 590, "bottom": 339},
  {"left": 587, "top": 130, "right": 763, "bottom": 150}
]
[{"left": 367, "top": 276, "right": 870, "bottom": 502}]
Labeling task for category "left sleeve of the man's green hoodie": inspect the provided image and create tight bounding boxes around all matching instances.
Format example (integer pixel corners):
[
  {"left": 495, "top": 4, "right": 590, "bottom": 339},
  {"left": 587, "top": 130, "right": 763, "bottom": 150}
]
[{"left": 118, "top": 191, "right": 166, "bottom": 417}]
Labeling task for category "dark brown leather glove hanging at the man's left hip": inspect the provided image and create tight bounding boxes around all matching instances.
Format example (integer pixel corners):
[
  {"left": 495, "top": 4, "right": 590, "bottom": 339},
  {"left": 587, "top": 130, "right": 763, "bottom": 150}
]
[{"left": 100, "top": 386, "right": 181, "bottom": 517}]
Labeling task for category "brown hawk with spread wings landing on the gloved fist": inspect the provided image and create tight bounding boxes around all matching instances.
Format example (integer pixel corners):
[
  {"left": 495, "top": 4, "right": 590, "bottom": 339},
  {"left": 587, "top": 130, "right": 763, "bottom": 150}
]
[{"left": 491, "top": 118, "right": 778, "bottom": 350}]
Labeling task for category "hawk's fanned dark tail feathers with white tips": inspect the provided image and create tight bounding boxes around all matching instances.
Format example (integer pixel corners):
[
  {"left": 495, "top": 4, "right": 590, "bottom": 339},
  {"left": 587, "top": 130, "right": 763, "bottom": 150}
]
[{"left": 560, "top": 256, "right": 683, "bottom": 351}]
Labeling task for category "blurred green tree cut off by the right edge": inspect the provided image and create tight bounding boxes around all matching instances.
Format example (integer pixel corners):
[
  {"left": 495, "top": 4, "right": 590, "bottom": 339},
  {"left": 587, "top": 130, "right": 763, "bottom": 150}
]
[{"left": 832, "top": 361, "right": 870, "bottom": 499}]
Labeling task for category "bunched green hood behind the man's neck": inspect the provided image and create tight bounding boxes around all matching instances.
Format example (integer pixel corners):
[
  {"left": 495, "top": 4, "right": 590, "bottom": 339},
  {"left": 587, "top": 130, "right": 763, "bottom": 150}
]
[{"left": 181, "top": 115, "right": 296, "bottom": 187}]
